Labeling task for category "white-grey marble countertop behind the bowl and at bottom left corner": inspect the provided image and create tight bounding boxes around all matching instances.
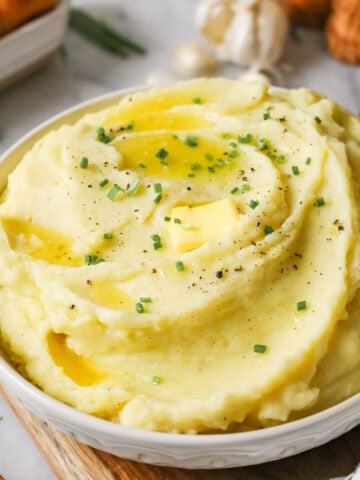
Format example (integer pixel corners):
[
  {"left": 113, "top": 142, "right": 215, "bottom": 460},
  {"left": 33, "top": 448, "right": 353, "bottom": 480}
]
[{"left": 0, "top": 0, "right": 360, "bottom": 480}]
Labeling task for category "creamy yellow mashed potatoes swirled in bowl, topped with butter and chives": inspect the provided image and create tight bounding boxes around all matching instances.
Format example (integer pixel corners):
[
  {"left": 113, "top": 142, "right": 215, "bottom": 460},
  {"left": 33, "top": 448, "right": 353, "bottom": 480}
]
[{"left": 0, "top": 79, "right": 360, "bottom": 433}]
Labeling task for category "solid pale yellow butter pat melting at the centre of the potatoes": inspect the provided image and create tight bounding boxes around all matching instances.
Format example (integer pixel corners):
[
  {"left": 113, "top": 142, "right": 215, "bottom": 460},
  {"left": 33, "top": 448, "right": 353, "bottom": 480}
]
[{"left": 168, "top": 197, "right": 239, "bottom": 253}]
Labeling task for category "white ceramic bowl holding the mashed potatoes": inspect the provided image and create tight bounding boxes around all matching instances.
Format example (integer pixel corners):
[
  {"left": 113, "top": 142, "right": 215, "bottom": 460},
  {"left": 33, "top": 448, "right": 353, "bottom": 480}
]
[{"left": 0, "top": 89, "right": 360, "bottom": 469}]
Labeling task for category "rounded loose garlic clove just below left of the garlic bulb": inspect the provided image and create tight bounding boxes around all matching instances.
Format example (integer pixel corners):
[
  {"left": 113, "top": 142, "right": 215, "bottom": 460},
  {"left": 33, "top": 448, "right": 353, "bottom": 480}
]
[{"left": 173, "top": 43, "right": 217, "bottom": 77}]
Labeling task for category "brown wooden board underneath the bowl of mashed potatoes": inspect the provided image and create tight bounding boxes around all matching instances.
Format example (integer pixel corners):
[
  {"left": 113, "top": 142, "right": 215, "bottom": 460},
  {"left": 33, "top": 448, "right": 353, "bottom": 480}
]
[{"left": 4, "top": 392, "right": 360, "bottom": 480}]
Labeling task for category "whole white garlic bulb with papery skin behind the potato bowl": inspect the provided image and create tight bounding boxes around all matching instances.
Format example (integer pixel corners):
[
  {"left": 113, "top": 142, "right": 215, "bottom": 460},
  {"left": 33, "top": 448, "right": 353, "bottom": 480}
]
[{"left": 195, "top": 0, "right": 288, "bottom": 70}]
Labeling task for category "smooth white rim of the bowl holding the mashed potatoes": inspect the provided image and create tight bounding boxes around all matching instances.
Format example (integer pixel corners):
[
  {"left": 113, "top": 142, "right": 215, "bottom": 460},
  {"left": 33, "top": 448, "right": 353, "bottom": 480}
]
[{"left": 0, "top": 83, "right": 360, "bottom": 448}]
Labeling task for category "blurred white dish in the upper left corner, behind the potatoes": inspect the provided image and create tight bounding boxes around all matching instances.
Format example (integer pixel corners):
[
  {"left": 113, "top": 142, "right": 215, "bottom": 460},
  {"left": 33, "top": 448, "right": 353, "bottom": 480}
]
[{"left": 0, "top": 0, "right": 70, "bottom": 88}]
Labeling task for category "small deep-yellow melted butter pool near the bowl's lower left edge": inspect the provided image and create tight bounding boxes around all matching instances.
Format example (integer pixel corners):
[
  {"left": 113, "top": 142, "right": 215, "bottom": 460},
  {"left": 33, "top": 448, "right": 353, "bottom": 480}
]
[{"left": 47, "top": 332, "right": 102, "bottom": 387}]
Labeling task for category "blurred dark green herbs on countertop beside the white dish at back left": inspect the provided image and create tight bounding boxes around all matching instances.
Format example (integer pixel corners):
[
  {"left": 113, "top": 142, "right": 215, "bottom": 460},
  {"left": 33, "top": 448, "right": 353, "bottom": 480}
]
[{"left": 69, "top": 8, "right": 146, "bottom": 58}]
